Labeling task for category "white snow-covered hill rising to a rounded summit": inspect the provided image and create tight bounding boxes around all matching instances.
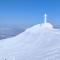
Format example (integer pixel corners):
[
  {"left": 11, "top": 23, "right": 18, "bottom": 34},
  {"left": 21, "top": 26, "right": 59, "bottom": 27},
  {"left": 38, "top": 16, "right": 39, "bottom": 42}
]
[{"left": 0, "top": 23, "right": 60, "bottom": 60}]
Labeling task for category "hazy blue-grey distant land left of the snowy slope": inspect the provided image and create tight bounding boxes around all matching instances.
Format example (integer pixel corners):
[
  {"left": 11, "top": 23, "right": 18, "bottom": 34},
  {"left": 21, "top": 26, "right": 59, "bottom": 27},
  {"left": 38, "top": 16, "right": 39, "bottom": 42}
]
[{"left": 0, "top": 26, "right": 24, "bottom": 40}]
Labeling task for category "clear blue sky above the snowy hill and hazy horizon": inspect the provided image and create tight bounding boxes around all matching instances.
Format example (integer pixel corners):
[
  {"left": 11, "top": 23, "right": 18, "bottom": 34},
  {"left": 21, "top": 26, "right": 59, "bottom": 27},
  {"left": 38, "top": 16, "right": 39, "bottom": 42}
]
[{"left": 0, "top": 0, "right": 60, "bottom": 27}]
